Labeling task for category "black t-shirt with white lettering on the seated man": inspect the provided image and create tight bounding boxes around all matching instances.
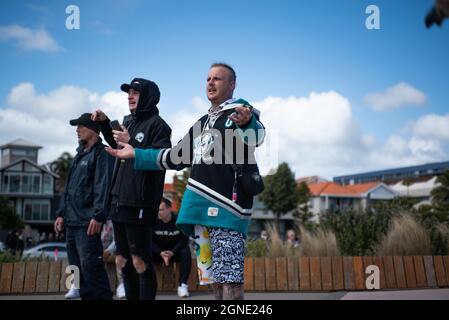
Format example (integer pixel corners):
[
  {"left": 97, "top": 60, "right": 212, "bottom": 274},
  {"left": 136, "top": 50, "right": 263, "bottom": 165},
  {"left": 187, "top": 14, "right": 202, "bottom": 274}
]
[{"left": 153, "top": 213, "right": 189, "bottom": 255}]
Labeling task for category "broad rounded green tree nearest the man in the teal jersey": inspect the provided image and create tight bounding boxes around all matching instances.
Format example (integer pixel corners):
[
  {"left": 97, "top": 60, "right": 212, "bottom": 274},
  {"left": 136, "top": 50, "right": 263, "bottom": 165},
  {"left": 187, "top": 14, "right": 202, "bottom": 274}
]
[{"left": 259, "top": 162, "right": 299, "bottom": 226}]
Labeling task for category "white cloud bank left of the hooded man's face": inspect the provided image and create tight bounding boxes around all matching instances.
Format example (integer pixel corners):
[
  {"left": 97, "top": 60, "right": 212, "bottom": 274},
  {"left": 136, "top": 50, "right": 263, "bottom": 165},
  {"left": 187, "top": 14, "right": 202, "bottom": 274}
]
[{"left": 0, "top": 83, "right": 129, "bottom": 163}]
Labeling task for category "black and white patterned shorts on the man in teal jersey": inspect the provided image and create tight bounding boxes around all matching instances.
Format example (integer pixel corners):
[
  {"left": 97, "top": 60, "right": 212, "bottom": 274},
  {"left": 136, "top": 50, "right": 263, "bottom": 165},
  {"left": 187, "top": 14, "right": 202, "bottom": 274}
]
[{"left": 209, "top": 228, "right": 245, "bottom": 283}]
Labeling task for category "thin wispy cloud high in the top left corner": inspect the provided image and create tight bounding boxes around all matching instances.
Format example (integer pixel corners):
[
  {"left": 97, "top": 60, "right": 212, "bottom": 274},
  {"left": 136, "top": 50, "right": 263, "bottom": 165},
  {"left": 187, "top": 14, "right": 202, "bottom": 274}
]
[{"left": 0, "top": 24, "right": 61, "bottom": 52}]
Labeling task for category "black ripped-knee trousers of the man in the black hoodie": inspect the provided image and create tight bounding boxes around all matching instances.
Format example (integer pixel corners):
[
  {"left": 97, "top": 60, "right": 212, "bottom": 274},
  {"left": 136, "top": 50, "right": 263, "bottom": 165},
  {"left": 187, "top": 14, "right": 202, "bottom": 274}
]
[{"left": 112, "top": 221, "right": 157, "bottom": 300}]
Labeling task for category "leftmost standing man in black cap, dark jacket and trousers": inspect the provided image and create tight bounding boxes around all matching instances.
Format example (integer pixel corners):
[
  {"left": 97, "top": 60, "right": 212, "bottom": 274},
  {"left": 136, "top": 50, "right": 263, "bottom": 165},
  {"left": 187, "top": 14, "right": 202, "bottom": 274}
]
[{"left": 54, "top": 113, "right": 114, "bottom": 300}]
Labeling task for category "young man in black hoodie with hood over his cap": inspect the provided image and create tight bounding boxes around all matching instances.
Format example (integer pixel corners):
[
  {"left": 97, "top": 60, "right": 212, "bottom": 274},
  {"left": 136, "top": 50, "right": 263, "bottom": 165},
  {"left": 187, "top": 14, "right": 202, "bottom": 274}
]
[{"left": 92, "top": 78, "right": 171, "bottom": 300}]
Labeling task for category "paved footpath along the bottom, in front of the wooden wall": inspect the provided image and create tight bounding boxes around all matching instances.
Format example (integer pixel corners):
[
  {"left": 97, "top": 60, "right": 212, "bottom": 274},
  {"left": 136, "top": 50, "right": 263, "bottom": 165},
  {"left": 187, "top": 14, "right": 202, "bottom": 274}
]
[{"left": 0, "top": 289, "right": 449, "bottom": 302}]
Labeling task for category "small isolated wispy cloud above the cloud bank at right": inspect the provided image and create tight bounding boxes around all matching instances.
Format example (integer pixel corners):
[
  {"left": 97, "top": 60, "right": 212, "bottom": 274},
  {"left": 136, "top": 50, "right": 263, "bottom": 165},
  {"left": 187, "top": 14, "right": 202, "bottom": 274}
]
[{"left": 365, "top": 82, "right": 427, "bottom": 111}]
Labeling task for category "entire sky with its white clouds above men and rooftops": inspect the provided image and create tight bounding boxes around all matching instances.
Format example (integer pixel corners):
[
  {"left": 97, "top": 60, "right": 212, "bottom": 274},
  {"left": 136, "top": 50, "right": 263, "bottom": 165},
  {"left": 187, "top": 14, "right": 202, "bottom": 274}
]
[{"left": 0, "top": 0, "right": 449, "bottom": 178}]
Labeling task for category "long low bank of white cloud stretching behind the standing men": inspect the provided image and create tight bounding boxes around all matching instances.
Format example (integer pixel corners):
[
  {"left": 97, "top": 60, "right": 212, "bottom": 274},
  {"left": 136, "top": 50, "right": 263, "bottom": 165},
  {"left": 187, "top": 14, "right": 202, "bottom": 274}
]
[{"left": 0, "top": 83, "right": 449, "bottom": 181}]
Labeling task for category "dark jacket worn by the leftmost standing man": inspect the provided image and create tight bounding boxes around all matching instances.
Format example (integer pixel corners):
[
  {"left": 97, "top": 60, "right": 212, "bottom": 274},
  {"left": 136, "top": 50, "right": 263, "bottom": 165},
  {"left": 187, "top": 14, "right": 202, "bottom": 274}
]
[{"left": 57, "top": 138, "right": 114, "bottom": 227}]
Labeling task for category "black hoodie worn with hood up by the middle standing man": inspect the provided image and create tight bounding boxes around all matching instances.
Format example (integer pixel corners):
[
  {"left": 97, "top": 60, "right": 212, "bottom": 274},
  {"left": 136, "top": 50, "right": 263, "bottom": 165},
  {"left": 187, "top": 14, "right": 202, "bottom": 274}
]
[{"left": 101, "top": 78, "right": 171, "bottom": 222}]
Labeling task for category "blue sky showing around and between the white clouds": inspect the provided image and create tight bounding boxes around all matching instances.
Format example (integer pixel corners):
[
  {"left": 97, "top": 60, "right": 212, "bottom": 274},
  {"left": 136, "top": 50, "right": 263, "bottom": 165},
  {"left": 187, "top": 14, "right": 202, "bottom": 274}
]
[{"left": 0, "top": 0, "right": 449, "bottom": 177}]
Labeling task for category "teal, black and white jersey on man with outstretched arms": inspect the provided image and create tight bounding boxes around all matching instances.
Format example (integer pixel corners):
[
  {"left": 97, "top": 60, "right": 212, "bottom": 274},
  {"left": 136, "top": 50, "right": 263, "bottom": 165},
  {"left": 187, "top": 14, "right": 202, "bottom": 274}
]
[{"left": 134, "top": 99, "right": 265, "bottom": 237}]
